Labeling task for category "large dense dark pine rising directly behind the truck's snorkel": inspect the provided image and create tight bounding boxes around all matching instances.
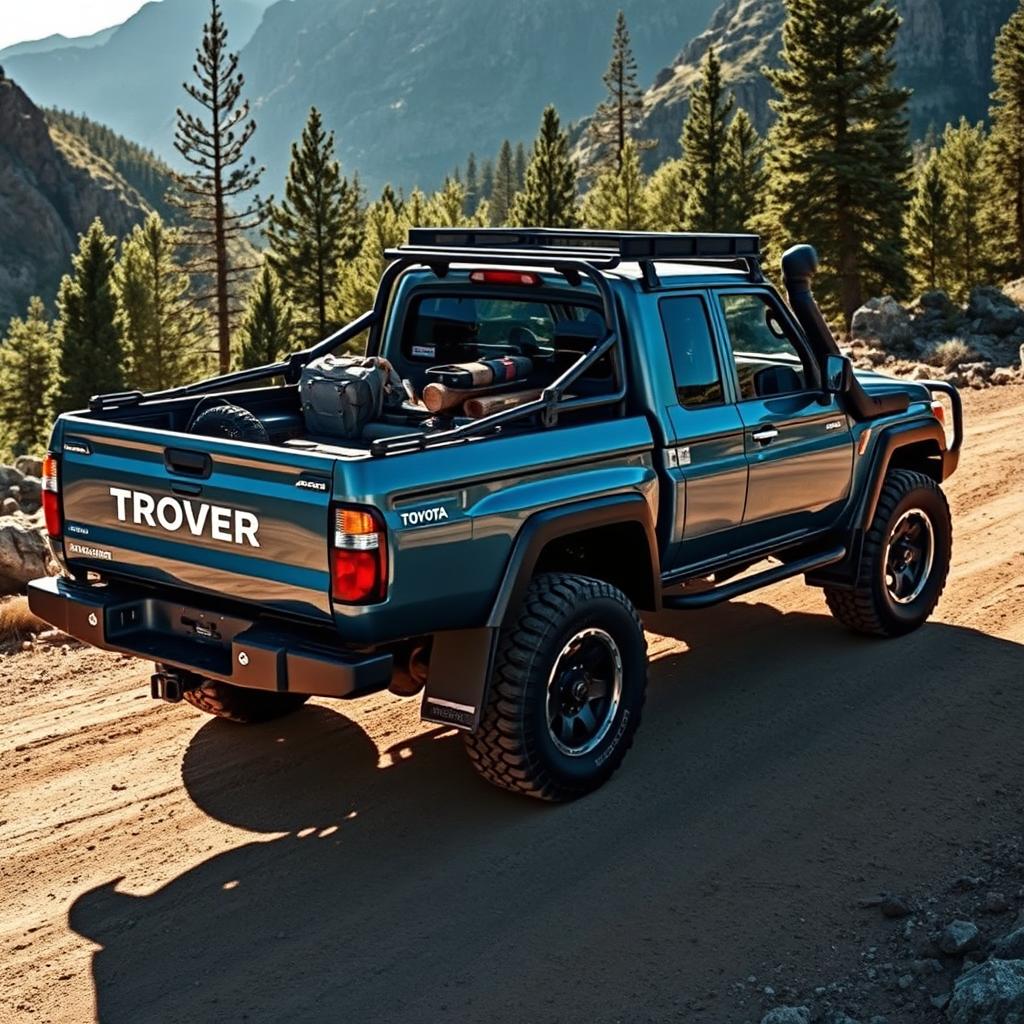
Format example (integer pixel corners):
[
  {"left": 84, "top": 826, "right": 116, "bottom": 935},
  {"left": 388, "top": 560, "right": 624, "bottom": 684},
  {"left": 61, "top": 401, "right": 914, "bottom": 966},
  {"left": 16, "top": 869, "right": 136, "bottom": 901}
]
[{"left": 762, "top": 0, "right": 910, "bottom": 325}]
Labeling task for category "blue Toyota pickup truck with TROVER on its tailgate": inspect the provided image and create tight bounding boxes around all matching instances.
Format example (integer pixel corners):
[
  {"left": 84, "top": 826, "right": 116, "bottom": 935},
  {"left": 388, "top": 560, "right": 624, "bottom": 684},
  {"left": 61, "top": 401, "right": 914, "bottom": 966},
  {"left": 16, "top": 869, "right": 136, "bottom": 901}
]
[{"left": 30, "top": 228, "right": 964, "bottom": 801}]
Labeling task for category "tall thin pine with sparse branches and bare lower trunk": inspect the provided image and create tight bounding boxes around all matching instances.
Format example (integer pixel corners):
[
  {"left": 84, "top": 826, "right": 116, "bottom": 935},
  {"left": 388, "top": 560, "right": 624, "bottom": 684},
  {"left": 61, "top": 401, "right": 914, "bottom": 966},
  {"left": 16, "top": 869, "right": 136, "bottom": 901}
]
[{"left": 174, "top": 0, "right": 265, "bottom": 373}]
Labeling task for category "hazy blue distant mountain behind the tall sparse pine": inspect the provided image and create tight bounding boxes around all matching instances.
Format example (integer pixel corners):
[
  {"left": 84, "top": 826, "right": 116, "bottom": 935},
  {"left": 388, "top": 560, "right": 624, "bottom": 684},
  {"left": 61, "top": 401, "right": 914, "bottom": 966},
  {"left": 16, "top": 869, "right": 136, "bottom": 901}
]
[{"left": 4, "top": 0, "right": 720, "bottom": 191}]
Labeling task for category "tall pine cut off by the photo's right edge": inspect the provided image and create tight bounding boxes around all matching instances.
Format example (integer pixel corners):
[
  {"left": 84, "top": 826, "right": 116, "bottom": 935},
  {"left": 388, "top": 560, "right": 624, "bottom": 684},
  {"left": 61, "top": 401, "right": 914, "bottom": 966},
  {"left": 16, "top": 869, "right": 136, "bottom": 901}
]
[{"left": 988, "top": 4, "right": 1024, "bottom": 276}]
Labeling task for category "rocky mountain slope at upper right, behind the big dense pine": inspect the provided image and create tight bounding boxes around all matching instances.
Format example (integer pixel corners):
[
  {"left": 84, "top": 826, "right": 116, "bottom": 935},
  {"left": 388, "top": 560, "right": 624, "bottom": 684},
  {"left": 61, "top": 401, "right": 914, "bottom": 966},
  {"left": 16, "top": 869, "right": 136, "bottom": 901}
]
[{"left": 643, "top": 0, "right": 1017, "bottom": 162}]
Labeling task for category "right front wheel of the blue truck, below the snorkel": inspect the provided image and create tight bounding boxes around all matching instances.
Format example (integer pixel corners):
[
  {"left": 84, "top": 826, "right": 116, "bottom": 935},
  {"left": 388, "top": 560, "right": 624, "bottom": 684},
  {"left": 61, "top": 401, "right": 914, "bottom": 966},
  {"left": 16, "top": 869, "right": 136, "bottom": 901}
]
[{"left": 825, "top": 469, "right": 952, "bottom": 637}]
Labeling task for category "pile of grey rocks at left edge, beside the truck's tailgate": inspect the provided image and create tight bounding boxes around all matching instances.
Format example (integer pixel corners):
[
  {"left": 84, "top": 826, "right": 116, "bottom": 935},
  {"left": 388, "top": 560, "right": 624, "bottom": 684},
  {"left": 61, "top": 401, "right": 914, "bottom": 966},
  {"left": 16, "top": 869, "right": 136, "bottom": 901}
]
[{"left": 0, "top": 457, "right": 52, "bottom": 594}]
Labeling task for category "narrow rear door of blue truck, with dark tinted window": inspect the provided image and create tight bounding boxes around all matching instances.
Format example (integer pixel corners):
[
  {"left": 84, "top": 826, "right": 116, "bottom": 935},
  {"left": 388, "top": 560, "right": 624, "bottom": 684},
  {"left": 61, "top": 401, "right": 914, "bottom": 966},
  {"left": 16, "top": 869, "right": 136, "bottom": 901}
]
[{"left": 658, "top": 293, "right": 748, "bottom": 568}]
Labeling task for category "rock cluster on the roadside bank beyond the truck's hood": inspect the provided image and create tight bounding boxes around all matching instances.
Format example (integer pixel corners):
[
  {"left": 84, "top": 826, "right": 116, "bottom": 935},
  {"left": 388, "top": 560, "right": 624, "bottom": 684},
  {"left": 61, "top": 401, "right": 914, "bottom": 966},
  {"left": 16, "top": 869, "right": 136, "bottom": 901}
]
[{"left": 847, "top": 286, "right": 1024, "bottom": 388}]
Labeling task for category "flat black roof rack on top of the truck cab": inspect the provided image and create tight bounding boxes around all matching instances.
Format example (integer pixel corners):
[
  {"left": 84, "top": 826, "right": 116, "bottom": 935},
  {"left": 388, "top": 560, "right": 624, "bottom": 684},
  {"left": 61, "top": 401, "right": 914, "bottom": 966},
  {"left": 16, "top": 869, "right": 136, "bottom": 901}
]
[{"left": 393, "top": 227, "right": 762, "bottom": 288}]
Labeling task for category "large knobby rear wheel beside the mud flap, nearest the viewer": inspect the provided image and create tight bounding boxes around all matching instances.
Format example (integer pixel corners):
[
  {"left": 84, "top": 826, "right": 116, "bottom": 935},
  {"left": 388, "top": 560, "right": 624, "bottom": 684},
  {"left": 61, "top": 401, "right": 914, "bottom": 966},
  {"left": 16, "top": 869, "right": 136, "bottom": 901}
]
[{"left": 464, "top": 573, "right": 647, "bottom": 801}]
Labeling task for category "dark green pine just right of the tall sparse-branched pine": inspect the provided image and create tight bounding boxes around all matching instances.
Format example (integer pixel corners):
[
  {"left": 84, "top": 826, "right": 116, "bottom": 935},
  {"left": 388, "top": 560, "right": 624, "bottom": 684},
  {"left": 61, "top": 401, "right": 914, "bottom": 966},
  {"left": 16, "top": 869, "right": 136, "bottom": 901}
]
[{"left": 266, "top": 106, "right": 352, "bottom": 342}]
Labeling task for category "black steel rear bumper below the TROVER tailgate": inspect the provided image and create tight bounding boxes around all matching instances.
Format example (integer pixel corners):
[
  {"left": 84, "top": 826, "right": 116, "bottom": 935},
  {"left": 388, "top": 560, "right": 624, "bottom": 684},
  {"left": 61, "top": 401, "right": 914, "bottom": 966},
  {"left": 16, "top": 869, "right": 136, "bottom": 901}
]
[{"left": 29, "top": 577, "right": 393, "bottom": 697}]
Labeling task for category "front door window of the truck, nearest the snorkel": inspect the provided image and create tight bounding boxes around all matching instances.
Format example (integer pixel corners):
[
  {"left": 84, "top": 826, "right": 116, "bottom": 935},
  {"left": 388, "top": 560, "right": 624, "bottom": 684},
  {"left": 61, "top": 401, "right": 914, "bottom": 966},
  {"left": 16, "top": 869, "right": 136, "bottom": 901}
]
[{"left": 719, "top": 295, "right": 811, "bottom": 399}]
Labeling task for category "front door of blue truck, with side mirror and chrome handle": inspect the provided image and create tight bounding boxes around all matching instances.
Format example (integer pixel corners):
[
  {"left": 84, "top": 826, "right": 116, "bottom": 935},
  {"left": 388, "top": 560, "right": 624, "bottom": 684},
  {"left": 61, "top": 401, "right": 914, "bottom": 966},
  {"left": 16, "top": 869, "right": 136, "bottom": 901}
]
[{"left": 716, "top": 289, "right": 853, "bottom": 544}]
